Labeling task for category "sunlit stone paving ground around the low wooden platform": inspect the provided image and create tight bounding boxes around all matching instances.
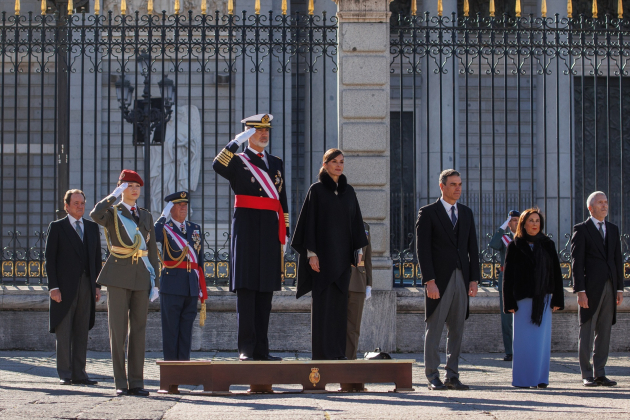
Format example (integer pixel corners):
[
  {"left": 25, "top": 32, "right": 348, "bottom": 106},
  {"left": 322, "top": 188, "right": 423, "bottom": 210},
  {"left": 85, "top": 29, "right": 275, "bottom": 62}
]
[{"left": 0, "top": 351, "right": 630, "bottom": 420}]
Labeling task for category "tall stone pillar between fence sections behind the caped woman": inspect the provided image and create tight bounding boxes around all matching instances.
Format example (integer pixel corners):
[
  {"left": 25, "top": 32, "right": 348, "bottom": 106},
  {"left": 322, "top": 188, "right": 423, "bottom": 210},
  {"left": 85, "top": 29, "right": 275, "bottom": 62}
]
[{"left": 337, "top": 0, "right": 396, "bottom": 351}]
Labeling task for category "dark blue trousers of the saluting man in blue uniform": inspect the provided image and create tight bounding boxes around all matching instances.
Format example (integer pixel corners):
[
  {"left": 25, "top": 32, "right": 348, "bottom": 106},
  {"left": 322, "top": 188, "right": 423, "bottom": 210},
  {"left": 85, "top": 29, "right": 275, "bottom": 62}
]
[{"left": 160, "top": 293, "right": 198, "bottom": 360}]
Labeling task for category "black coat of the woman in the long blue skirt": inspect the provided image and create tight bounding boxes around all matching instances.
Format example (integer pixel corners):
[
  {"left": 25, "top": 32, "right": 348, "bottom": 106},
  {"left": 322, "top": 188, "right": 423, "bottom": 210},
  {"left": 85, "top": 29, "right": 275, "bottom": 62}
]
[{"left": 503, "top": 237, "right": 564, "bottom": 314}]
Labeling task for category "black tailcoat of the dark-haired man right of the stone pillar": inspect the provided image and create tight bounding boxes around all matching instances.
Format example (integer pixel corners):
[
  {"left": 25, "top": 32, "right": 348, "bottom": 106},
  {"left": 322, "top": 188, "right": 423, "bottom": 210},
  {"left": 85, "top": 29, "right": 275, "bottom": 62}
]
[{"left": 416, "top": 199, "right": 480, "bottom": 319}]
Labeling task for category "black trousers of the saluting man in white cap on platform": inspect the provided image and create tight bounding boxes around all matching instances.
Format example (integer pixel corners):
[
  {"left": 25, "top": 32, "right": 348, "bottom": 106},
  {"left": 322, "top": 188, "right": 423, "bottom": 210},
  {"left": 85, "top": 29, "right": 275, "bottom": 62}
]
[{"left": 236, "top": 289, "right": 273, "bottom": 358}]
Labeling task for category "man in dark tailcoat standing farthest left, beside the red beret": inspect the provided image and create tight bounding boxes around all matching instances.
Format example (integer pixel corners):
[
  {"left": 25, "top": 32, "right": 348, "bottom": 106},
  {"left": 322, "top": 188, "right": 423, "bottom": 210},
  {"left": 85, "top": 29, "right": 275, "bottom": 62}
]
[{"left": 46, "top": 190, "right": 102, "bottom": 385}]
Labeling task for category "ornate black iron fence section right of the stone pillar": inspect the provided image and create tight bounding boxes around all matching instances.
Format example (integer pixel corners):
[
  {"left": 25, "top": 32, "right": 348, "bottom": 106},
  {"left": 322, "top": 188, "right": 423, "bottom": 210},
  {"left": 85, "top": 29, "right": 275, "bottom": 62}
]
[{"left": 390, "top": 14, "right": 630, "bottom": 285}]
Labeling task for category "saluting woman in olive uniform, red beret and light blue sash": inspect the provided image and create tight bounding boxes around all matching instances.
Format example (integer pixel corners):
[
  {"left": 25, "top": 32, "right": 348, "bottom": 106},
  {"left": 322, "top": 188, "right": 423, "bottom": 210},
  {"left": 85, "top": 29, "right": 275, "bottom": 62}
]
[{"left": 90, "top": 169, "right": 160, "bottom": 396}]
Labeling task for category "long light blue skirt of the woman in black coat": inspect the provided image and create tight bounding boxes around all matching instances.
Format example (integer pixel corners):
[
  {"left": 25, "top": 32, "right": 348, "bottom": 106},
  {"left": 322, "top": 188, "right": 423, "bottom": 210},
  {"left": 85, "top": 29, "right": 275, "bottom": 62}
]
[{"left": 512, "top": 297, "right": 551, "bottom": 387}]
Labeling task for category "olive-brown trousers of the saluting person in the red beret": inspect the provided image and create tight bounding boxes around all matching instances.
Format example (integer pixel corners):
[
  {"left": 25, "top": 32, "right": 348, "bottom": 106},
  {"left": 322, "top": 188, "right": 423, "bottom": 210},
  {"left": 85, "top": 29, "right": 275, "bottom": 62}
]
[{"left": 107, "top": 286, "right": 149, "bottom": 389}]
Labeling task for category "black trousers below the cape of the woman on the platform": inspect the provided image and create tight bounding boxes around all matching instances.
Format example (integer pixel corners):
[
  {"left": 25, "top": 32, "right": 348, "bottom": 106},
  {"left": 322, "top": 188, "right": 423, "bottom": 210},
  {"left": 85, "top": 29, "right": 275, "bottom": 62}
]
[{"left": 311, "top": 267, "right": 351, "bottom": 360}]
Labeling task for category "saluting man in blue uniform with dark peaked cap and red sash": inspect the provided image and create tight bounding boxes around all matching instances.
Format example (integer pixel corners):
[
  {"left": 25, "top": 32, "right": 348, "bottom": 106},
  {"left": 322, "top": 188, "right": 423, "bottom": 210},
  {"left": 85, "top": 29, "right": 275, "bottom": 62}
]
[{"left": 155, "top": 191, "right": 208, "bottom": 360}]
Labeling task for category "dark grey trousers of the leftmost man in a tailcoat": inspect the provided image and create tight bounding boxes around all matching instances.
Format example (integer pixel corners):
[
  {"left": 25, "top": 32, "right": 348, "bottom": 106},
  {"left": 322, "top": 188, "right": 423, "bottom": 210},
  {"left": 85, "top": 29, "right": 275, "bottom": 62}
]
[{"left": 55, "top": 274, "right": 92, "bottom": 381}]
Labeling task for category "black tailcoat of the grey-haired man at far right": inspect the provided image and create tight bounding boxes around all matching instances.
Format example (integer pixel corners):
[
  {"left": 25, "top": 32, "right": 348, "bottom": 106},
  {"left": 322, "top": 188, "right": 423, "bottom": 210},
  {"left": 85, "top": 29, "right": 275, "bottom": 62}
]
[{"left": 571, "top": 219, "right": 623, "bottom": 325}]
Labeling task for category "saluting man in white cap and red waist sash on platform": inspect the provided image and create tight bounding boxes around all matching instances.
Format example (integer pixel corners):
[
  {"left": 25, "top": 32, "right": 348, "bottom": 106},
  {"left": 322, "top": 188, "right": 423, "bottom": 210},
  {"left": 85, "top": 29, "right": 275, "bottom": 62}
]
[{"left": 212, "top": 114, "right": 289, "bottom": 361}]
